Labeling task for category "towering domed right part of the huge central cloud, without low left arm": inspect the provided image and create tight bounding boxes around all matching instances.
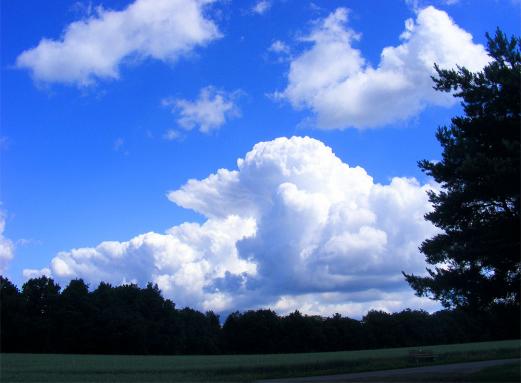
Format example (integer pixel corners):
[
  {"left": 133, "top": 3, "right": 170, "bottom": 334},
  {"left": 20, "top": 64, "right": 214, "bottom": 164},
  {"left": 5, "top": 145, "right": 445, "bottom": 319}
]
[{"left": 169, "top": 137, "right": 434, "bottom": 293}]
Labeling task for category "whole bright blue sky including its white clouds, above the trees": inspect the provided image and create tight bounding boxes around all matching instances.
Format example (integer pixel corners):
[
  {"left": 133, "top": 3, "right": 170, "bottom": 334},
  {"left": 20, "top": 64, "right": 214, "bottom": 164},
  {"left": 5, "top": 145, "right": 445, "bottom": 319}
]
[{"left": 0, "top": 0, "right": 520, "bottom": 316}]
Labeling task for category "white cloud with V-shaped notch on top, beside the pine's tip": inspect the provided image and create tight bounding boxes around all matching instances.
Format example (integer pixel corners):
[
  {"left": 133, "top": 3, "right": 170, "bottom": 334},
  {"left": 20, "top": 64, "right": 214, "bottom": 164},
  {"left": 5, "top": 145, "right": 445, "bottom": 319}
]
[{"left": 276, "top": 6, "right": 490, "bottom": 129}]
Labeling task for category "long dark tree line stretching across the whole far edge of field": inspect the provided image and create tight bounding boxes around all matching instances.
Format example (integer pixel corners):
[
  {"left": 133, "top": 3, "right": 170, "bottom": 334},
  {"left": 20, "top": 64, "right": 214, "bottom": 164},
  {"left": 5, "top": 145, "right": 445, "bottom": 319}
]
[{"left": 0, "top": 276, "right": 519, "bottom": 354}]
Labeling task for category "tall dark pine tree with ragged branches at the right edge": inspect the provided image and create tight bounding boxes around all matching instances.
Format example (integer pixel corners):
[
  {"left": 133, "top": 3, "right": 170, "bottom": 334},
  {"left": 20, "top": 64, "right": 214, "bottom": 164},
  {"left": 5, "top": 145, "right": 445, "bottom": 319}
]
[{"left": 405, "top": 30, "right": 521, "bottom": 311}]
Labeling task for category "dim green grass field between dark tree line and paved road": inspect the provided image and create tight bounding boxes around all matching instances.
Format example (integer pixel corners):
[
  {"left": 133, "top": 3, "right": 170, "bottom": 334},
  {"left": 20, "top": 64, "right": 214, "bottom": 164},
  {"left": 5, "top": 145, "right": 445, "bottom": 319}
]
[{"left": 0, "top": 340, "right": 520, "bottom": 382}]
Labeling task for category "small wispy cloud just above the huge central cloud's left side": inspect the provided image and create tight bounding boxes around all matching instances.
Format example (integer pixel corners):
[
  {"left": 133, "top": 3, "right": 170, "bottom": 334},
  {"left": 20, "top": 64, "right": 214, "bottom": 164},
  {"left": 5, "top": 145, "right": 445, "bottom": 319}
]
[{"left": 162, "top": 86, "right": 240, "bottom": 134}]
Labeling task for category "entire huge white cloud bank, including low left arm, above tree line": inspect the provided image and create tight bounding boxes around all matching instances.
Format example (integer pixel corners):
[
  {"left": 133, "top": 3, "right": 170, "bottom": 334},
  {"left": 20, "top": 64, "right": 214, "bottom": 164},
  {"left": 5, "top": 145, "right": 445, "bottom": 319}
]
[{"left": 34, "top": 137, "right": 435, "bottom": 315}]
